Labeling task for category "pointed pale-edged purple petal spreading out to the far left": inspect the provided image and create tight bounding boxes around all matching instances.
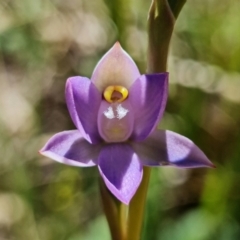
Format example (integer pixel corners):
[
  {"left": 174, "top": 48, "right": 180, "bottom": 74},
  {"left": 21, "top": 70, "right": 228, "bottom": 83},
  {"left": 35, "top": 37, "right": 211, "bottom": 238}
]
[{"left": 39, "top": 130, "right": 101, "bottom": 167}]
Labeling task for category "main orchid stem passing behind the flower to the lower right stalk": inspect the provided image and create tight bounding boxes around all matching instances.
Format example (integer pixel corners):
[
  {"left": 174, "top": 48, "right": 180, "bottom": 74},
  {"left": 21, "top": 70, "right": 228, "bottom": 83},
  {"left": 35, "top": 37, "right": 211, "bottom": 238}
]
[{"left": 127, "top": 0, "right": 186, "bottom": 240}]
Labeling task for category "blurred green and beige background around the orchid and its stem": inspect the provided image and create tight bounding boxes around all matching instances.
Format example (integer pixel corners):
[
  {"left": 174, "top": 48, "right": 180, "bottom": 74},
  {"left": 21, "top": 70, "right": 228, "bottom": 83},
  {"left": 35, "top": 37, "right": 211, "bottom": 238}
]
[{"left": 0, "top": 0, "right": 240, "bottom": 240}]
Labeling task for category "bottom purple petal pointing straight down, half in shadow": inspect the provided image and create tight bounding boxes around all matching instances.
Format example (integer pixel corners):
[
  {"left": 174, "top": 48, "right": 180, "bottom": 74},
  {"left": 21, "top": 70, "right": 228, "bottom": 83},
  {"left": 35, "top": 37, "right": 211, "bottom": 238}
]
[{"left": 98, "top": 144, "right": 143, "bottom": 204}]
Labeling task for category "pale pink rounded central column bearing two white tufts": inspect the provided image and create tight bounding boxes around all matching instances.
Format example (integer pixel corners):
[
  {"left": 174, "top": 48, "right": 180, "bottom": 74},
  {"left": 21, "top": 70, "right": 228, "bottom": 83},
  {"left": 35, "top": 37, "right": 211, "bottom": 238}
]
[{"left": 98, "top": 100, "right": 134, "bottom": 142}]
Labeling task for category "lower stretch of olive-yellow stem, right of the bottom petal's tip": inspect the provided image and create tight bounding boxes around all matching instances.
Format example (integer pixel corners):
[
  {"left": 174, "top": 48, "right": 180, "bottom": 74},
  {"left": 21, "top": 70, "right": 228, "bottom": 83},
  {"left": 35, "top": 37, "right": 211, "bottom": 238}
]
[{"left": 127, "top": 167, "right": 151, "bottom": 240}]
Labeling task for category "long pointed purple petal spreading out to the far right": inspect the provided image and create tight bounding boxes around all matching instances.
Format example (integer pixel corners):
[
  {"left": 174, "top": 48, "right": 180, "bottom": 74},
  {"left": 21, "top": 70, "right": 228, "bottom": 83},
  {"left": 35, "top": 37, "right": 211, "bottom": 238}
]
[{"left": 131, "top": 130, "right": 214, "bottom": 168}]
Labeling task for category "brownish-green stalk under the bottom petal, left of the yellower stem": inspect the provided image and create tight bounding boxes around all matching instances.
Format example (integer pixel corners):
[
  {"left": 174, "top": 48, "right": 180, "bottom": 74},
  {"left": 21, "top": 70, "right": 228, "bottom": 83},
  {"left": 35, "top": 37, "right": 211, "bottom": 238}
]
[{"left": 99, "top": 178, "right": 128, "bottom": 240}]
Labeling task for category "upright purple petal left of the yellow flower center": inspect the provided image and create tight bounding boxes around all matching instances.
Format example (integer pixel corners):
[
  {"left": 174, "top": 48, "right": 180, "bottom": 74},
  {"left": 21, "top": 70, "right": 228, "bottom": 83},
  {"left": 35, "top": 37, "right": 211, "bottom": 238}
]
[{"left": 65, "top": 77, "right": 102, "bottom": 143}]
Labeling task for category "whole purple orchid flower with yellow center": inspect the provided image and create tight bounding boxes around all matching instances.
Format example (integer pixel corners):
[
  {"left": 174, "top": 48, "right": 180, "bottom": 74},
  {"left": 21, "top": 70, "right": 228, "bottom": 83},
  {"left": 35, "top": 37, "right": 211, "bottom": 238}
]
[{"left": 40, "top": 43, "right": 213, "bottom": 204}]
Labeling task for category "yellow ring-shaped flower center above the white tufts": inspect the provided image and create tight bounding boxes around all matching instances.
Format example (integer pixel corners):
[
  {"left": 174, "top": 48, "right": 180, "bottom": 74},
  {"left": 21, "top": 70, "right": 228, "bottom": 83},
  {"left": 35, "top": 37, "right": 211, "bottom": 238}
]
[{"left": 103, "top": 85, "right": 128, "bottom": 103}]
